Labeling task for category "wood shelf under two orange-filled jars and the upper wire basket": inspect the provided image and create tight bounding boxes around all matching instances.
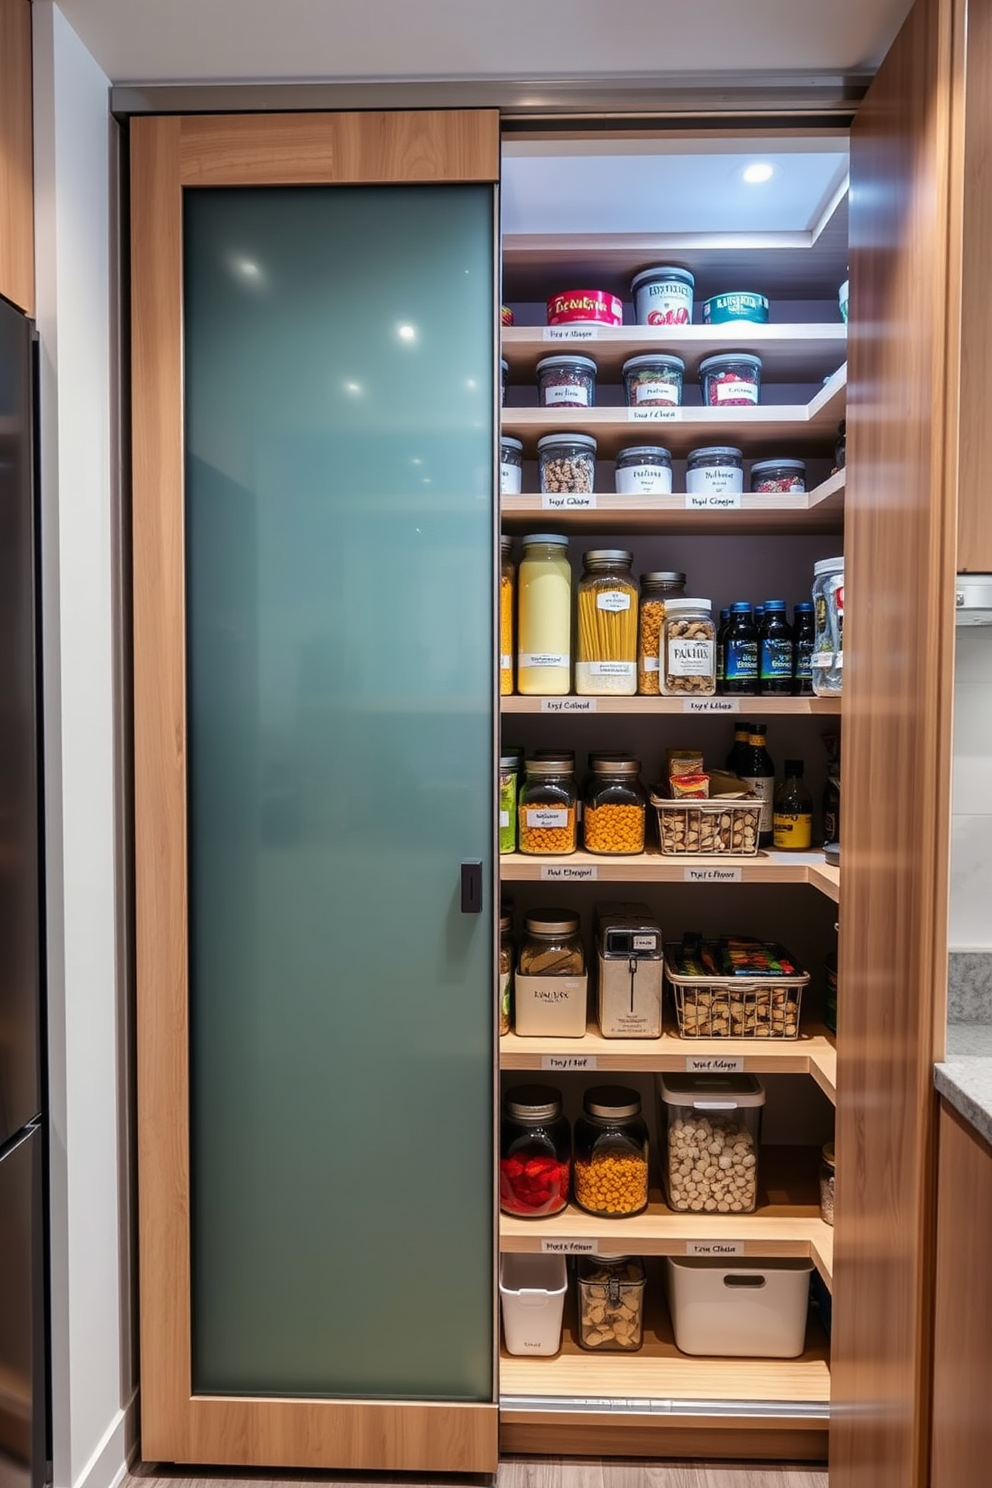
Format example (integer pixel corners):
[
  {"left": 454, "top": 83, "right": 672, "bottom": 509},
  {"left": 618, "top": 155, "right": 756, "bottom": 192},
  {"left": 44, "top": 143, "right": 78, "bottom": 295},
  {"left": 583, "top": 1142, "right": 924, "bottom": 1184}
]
[{"left": 500, "top": 848, "right": 840, "bottom": 903}]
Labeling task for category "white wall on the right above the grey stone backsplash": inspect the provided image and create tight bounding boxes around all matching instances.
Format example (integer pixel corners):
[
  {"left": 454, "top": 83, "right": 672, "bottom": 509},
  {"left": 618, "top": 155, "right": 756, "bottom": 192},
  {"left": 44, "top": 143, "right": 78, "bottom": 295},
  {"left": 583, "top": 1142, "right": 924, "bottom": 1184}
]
[{"left": 949, "top": 626, "right": 992, "bottom": 951}]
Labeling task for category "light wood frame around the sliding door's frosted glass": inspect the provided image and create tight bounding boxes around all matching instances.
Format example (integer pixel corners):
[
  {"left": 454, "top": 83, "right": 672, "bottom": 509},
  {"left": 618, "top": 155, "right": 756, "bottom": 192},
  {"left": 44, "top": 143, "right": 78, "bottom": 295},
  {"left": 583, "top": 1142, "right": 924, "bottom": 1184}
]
[{"left": 131, "top": 110, "right": 500, "bottom": 1473}]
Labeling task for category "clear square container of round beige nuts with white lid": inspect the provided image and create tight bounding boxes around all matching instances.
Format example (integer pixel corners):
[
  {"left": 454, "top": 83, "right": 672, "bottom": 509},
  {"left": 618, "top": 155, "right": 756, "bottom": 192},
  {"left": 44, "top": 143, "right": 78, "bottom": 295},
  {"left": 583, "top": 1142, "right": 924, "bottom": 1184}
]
[{"left": 657, "top": 1074, "right": 764, "bottom": 1214}]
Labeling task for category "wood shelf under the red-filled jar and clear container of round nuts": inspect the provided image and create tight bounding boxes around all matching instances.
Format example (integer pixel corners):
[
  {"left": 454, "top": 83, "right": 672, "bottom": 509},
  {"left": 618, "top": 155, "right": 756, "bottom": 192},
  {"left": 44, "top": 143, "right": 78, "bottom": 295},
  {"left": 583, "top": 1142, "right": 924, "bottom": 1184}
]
[{"left": 500, "top": 1147, "right": 833, "bottom": 1287}]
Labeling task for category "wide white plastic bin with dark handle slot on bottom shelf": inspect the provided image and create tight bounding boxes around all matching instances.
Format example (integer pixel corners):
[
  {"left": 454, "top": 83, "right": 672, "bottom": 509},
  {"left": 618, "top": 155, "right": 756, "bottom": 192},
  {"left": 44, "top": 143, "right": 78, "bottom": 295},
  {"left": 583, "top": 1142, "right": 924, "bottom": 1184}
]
[{"left": 666, "top": 1256, "right": 814, "bottom": 1359}]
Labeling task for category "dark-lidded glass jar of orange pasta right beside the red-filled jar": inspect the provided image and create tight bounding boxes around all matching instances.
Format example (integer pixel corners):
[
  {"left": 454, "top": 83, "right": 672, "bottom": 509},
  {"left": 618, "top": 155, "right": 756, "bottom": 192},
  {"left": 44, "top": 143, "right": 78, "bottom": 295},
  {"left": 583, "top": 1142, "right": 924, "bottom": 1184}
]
[{"left": 573, "top": 1085, "right": 647, "bottom": 1217}]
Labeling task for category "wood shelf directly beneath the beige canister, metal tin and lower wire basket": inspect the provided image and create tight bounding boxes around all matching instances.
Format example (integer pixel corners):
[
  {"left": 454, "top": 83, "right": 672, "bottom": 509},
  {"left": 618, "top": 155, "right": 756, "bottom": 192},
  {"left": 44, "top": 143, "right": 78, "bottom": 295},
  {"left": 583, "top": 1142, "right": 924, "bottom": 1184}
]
[{"left": 500, "top": 1024, "right": 837, "bottom": 1100}]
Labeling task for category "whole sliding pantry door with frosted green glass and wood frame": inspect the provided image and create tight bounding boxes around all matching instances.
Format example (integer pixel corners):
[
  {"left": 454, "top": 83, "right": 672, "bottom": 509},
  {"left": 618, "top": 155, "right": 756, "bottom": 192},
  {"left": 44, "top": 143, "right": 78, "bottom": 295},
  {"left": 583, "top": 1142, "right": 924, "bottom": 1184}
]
[{"left": 131, "top": 110, "right": 500, "bottom": 1473}]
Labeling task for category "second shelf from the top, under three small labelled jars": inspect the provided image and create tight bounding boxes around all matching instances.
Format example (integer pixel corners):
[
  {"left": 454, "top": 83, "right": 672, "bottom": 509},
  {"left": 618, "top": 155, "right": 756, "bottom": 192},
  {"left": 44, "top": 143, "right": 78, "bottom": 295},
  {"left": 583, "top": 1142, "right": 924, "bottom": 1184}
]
[{"left": 501, "top": 365, "right": 848, "bottom": 460}]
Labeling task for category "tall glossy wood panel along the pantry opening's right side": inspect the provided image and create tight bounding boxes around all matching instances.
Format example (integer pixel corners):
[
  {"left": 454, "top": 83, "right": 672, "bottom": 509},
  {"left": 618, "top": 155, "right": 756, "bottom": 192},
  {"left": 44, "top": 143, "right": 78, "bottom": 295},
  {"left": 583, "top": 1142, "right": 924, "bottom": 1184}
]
[{"left": 830, "top": 0, "right": 959, "bottom": 1488}]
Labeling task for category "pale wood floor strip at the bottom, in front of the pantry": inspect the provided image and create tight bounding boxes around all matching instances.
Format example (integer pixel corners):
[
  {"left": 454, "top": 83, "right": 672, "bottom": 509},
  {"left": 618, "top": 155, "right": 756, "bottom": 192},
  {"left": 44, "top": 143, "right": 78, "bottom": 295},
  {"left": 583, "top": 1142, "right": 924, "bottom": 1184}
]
[{"left": 131, "top": 1457, "right": 827, "bottom": 1488}]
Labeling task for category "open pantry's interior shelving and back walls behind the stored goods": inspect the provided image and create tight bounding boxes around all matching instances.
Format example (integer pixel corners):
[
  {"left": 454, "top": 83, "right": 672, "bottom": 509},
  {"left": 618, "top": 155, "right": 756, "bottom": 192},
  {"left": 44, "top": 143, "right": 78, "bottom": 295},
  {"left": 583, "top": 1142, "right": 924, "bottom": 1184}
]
[{"left": 498, "top": 128, "right": 848, "bottom": 1458}]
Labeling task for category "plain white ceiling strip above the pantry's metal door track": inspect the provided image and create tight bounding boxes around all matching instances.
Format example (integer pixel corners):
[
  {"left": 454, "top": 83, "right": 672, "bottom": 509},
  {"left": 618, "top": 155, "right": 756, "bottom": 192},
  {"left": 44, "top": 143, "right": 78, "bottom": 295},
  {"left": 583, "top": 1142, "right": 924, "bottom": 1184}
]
[{"left": 58, "top": 0, "right": 910, "bottom": 83}]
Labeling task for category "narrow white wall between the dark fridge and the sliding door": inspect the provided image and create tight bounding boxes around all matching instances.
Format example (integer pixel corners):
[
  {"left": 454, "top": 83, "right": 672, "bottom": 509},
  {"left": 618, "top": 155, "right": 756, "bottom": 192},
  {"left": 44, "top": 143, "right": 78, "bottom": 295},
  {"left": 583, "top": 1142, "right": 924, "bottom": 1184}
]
[{"left": 33, "top": 11, "right": 134, "bottom": 1488}]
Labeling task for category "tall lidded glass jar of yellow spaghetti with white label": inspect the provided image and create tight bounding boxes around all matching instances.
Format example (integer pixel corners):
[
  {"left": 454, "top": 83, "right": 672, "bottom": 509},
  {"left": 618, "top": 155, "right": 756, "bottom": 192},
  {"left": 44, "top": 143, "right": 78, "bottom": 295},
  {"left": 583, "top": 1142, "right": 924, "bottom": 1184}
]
[{"left": 576, "top": 548, "right": 638, "bottom": 698}]
